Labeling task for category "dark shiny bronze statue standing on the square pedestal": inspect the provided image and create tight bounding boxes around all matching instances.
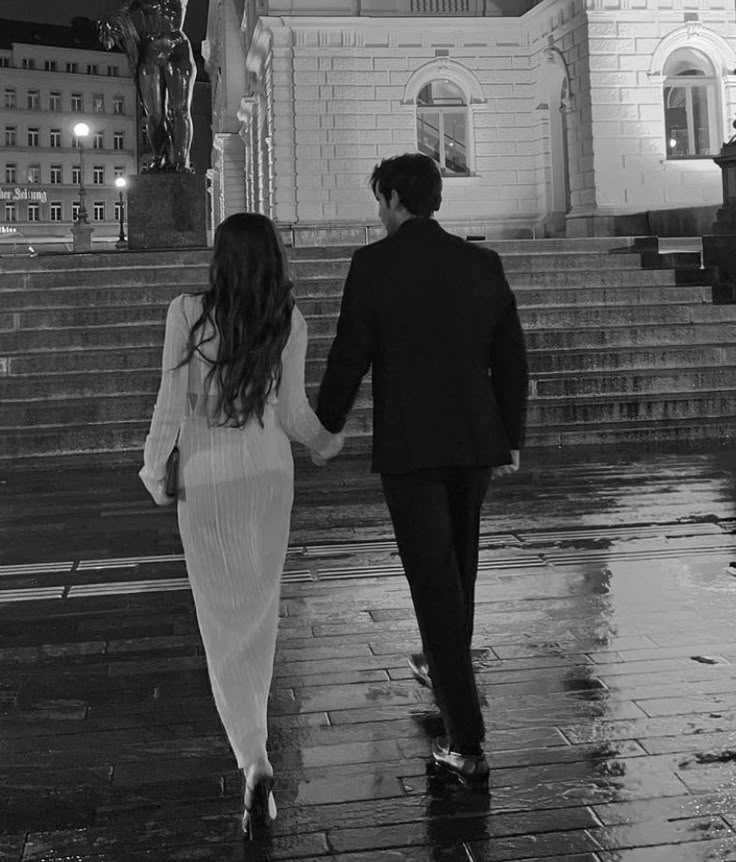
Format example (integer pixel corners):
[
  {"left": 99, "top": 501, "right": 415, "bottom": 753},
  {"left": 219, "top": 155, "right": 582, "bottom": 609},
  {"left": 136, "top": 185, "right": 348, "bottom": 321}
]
[{"left": 98, "top": 0, "right": 197, "bottom": 172}]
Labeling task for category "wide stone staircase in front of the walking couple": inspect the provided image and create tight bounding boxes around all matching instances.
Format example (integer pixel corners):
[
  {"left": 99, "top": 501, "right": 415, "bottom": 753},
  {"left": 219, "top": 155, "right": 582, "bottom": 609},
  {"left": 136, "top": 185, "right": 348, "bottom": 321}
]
[{"left": 0, "top": 237, "right": 736, "bottom": 466}]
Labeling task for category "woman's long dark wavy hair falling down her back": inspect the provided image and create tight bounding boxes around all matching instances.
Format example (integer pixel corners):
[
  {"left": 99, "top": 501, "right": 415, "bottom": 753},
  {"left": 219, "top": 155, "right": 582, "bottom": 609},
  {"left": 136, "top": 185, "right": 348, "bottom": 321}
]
[{"left": 180, "top": 213, "right": 294, "bottom": 428}]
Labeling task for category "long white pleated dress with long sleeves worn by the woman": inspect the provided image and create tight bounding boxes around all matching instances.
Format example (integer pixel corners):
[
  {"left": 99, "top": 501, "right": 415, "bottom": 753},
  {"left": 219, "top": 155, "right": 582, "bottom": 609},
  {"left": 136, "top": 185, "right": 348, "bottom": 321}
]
[{"left": 139, "top": 294, "right": 339, "bottom": 768}]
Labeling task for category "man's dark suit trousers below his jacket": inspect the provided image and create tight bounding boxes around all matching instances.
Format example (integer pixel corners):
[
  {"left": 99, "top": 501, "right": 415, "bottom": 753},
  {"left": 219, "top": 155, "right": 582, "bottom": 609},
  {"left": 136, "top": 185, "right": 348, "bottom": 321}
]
[{"left": 381, "top": 467, "right": 491, "bottom": 754}]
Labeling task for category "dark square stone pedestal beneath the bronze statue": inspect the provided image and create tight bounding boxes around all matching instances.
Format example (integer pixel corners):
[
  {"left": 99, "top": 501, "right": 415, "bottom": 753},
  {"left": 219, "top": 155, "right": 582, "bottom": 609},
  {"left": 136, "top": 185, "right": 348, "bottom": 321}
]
[{"left": 128, "top": 173, "right": 207, "bottom": 249}]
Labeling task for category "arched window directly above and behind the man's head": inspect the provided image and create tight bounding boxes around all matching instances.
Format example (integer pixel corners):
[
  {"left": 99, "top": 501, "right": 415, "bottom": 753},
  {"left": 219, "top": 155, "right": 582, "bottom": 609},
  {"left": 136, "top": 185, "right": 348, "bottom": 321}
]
[{"left": 417, "top": 79, "right": 470, "bottom": 177}]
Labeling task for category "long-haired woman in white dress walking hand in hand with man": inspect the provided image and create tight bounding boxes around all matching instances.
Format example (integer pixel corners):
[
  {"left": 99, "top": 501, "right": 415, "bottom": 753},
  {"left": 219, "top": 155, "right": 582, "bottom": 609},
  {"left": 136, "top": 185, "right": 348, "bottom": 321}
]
[{"left": 139, "top": 213, "right": 343, "bottom": 836}]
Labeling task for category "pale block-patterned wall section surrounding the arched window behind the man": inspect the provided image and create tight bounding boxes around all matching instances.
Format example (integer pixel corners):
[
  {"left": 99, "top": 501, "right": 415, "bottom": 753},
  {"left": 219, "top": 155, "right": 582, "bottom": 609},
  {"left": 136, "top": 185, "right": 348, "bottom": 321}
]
[{"left": 248, "top": 18, "right": 539, "bottom": 233}]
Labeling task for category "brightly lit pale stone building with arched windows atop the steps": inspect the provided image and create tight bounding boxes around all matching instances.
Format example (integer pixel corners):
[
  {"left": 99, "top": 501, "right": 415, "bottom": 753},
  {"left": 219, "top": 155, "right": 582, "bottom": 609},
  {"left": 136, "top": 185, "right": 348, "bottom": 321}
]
[{"left": 204, "top": 0, "right": 736, "bottom": 242}]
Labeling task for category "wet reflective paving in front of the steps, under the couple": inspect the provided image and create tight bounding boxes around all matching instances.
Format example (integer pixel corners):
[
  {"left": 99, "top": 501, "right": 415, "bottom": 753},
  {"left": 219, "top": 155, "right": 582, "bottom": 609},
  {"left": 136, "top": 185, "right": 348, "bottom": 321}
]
[{"left": 0, "top": 449, "right": 736, "bottom": 862}]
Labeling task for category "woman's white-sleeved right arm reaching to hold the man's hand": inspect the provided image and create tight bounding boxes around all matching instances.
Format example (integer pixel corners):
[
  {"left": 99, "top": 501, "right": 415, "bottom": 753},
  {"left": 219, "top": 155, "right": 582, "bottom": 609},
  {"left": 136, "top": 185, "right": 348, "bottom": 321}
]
[{"left": 276, "top": 306, "right": 341, "bottom": 458}]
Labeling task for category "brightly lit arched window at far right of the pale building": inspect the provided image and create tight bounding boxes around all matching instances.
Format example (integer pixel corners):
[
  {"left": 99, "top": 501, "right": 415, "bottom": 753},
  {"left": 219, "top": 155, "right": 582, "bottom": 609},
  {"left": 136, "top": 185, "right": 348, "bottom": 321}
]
[{"left": 663, "top": 48, "right": 718, "bottom": 159}]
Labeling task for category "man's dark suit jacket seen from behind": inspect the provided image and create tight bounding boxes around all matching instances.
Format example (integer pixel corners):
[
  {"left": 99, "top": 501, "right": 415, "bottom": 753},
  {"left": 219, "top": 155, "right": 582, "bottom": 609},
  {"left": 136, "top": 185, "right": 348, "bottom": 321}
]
[{"left": 317, "top": 218, "right": 527, "bottom": 473}]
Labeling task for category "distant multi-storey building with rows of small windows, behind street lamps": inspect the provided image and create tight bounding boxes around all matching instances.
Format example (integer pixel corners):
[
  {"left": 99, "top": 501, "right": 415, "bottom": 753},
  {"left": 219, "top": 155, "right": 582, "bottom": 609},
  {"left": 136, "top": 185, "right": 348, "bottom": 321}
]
[{"left": 0, "top": 19, "right": 138, "bottom": 247}]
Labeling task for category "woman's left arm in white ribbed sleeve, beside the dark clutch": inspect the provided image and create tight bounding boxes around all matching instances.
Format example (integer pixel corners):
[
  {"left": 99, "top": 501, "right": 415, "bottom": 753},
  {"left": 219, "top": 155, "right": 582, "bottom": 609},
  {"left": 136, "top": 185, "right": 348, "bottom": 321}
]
[{"left": 138, "top": 296, "right": 189, "bottom": 500}]
